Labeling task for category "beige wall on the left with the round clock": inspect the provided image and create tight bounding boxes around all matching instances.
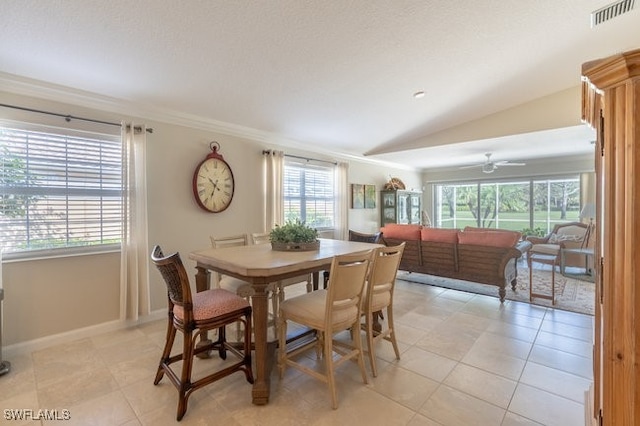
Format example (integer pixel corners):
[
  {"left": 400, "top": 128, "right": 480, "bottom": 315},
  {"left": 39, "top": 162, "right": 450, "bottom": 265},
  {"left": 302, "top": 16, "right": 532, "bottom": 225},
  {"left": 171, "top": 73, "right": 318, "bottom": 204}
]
[{"left": 0, "top": 93, "right": 421, "bottom": 352}]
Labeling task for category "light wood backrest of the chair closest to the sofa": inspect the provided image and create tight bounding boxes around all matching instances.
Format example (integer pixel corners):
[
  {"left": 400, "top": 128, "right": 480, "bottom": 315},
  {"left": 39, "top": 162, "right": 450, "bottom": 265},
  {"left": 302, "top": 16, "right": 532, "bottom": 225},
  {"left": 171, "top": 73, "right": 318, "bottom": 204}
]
[{"left": 364, "top": 242, "right": 406, "bottom": 311}]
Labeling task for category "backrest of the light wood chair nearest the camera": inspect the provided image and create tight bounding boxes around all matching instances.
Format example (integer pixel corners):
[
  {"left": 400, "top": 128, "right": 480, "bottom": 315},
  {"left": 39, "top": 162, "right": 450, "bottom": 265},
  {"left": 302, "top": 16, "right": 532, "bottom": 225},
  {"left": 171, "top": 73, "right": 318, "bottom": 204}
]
[{"left": 325, "top": 251, "right": 371, "bottom": 329}]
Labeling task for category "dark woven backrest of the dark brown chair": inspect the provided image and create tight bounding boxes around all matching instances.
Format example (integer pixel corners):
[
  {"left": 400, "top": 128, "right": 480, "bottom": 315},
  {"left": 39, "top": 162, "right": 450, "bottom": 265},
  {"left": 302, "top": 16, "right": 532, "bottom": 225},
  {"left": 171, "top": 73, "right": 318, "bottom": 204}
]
[{"left": 151, "top": 245, "right": 192, "bottom": 318}]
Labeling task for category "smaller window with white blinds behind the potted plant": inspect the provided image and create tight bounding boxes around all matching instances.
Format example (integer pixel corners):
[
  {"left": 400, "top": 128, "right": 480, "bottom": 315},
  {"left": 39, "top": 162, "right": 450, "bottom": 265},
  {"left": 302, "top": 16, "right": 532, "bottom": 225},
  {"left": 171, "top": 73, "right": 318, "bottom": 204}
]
[{"left": 284, "top": 160, "right": 335, "bottom": 229}]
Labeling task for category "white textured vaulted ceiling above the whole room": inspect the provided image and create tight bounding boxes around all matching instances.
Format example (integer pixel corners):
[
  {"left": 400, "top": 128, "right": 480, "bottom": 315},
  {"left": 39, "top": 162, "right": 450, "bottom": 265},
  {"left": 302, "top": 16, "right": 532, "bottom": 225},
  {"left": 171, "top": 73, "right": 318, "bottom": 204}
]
[{"left": 0, "top": 0, "right": 640, "bottom": 168}]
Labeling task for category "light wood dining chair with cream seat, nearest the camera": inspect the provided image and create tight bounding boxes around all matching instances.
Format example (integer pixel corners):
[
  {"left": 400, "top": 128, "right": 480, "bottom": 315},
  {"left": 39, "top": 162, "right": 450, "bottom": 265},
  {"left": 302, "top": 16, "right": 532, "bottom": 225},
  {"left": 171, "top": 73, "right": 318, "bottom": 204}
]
[{"left": 278, "top": 251, "right": 371, "bottom": 409}]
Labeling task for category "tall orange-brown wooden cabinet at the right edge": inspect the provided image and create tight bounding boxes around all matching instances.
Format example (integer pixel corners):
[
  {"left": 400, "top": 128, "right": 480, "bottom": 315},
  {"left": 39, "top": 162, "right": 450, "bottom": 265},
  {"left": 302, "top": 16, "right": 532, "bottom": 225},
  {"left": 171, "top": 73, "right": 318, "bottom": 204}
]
[{"left": 582, "top": 49, "right": 640, "bottom": 426}]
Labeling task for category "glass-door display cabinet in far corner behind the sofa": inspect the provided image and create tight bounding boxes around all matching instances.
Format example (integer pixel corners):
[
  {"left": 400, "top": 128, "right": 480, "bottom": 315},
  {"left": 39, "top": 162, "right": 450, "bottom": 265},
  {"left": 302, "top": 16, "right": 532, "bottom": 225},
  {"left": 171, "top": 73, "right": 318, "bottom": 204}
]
[{"left": 380, "top": 189, "right": 422, "bottom": 226}]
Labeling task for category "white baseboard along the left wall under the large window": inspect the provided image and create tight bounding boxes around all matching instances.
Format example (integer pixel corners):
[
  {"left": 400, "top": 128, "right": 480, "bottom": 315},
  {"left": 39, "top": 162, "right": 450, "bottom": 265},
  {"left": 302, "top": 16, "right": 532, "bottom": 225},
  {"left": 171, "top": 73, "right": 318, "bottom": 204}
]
[{"left": 0, "top": 308, "right": 167, "bottom": 361}]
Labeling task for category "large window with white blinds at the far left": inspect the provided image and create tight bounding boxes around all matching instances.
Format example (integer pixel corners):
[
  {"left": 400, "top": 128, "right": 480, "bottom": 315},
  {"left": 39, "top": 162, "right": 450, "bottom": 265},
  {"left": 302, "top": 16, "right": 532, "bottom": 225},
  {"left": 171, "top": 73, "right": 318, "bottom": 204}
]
[{"left": 0, "top": 126, "right": 122, "bottom": 256}]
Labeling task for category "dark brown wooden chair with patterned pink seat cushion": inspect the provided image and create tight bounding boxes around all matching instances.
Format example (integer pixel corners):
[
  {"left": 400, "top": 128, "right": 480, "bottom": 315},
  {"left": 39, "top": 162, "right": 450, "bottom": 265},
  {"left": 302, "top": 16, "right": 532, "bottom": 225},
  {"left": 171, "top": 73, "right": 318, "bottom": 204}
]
[{"left": 151, "top": 246, "right": 253, "bottom": 421}]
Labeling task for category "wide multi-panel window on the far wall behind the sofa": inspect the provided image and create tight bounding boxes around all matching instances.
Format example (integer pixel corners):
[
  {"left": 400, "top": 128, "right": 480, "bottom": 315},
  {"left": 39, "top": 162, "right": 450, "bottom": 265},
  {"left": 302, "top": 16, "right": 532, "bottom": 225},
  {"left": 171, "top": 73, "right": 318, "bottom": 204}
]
[{"left": 433, "top": 176, "right": 580, "bottom": 233}]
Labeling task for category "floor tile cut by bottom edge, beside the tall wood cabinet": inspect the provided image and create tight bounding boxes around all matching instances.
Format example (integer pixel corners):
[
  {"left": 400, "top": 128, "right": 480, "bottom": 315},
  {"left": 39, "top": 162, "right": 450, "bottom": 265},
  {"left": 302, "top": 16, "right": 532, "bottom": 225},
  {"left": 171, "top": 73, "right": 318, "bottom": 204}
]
[{"left": 509, "top": 384, "right": 584, "bottom": 426}]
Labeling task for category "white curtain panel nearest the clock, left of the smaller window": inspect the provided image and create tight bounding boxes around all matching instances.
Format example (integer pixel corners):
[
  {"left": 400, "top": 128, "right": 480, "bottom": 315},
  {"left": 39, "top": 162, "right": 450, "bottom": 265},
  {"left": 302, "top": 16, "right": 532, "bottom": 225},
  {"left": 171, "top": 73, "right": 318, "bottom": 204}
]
[{"left": 262, "top": 150, "right": 284, "bottom": 232}]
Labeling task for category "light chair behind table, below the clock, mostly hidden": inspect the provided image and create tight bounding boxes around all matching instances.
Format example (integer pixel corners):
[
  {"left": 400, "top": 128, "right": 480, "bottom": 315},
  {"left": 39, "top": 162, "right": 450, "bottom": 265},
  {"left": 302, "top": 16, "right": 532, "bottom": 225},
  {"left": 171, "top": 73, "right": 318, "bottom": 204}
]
[{"left": 209, "top": 234, "right": 278, "bottom": 339}]
